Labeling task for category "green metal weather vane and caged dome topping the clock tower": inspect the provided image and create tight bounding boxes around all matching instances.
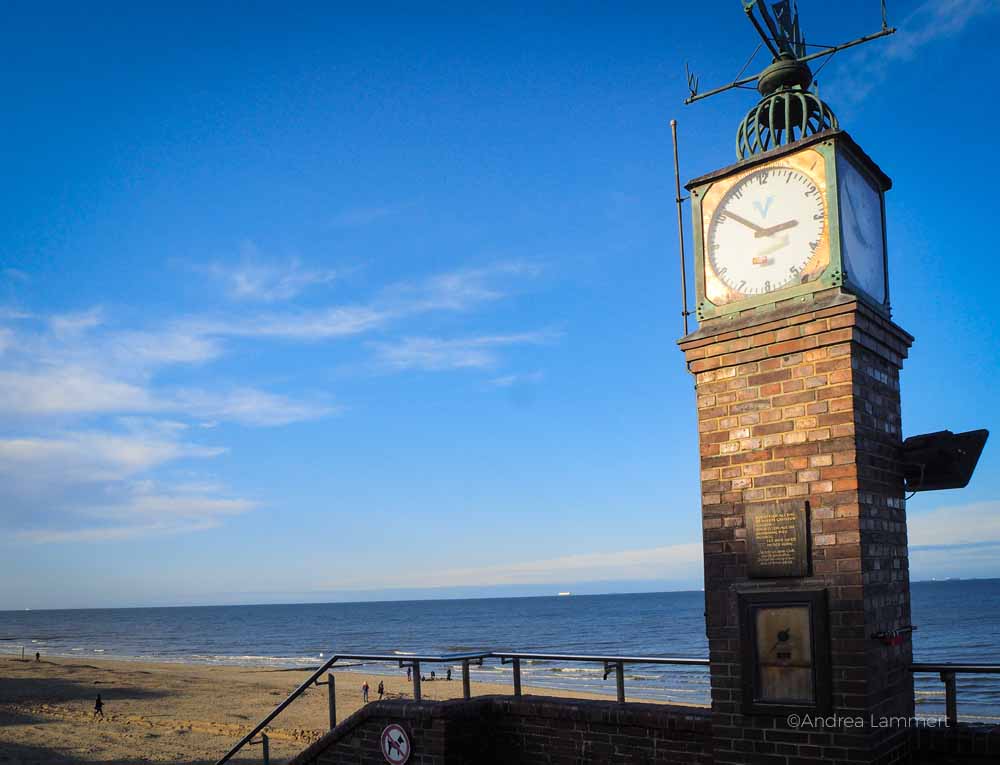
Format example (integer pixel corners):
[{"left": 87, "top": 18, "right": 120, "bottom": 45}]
[{"left": 684, "top": 0, "right": 896, "bottom": 159}]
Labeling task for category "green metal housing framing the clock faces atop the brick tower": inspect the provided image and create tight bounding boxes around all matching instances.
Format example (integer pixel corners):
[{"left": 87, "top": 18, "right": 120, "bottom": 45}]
[{"left": 685, "top": 130, "right": 892, "bottom": 322}]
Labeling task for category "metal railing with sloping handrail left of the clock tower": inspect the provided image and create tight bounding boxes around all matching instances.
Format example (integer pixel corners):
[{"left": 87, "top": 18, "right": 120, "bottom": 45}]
[{"left": 216, "top": 651, "right": 708, "bottom": 765}]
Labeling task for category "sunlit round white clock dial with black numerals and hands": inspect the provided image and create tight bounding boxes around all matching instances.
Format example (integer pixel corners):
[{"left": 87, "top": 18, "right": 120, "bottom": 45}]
[{"left": 705, "top": 165, "right": 827, "bottom": 295}]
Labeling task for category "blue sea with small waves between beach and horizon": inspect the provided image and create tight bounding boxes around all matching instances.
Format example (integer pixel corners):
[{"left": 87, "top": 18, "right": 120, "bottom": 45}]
[{"left": 0, "top": 579, "right": 1000, "bottom": 722}]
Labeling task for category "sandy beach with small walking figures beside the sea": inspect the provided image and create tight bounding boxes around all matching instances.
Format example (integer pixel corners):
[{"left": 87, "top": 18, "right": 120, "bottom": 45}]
[{"left": 0, "top": 657, "right": 688, "bottom": 765}]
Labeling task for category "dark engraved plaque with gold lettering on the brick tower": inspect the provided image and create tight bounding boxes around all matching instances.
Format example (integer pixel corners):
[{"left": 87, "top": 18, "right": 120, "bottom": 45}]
[{"left": 746, "top": 504, "right": 809, "bottom": 579}]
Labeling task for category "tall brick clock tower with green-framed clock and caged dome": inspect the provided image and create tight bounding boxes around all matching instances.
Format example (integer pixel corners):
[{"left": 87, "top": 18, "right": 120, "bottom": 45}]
[{"left": 680, "top": 19, "right": 914, "bottom": 765}]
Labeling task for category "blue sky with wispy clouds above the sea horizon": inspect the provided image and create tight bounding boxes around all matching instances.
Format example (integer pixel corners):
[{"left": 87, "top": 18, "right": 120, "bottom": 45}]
[{"left": 0, "top": 0, "right": 1000, "bottom": 609}]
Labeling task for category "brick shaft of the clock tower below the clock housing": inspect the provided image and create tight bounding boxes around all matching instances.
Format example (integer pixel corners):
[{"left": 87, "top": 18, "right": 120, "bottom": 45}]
[{"left": 680, "top": 290, "right": 913, "bottom": 765}]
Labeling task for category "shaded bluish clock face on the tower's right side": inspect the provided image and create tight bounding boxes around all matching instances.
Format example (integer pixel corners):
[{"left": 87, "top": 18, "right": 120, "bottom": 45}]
[{"left": 837, "top": 151, "right": 885, "bottom": 303}]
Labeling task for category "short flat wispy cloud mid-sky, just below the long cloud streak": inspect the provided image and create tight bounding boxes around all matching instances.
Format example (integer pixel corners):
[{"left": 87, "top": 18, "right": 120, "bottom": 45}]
[{"left": 372, "top": 332, "right": 556, "bottom": 372}]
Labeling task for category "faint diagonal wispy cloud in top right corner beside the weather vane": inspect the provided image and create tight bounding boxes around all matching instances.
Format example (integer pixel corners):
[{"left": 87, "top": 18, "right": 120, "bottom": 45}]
[{"left": 824, "top": 0, "right": 1000, "bottom": 107}]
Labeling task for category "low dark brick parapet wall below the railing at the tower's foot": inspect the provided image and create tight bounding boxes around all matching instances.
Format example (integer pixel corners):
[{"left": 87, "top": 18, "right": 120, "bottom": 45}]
[{"left": 289, "top": 696, "right": 1000, "bottom": 765}]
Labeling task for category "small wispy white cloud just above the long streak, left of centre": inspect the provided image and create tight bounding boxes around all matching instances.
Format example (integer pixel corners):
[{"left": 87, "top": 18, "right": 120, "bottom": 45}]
[{"left": 205, "top": 243, "right": 339, "bottom": 303}]
